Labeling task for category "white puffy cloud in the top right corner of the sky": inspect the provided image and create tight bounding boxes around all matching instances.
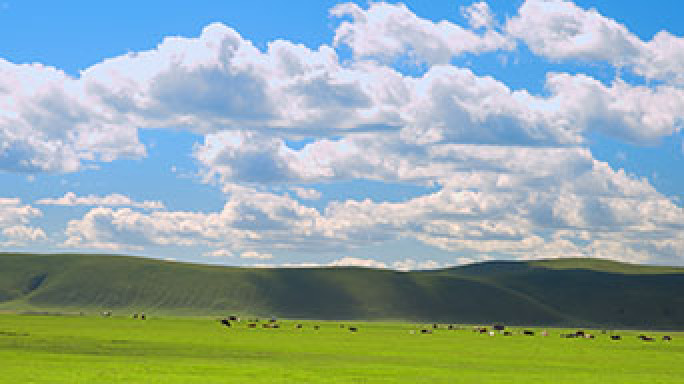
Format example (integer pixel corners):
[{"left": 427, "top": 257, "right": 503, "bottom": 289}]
[{"left": 506, "top": 0, "right": 684, "bottom": 84}]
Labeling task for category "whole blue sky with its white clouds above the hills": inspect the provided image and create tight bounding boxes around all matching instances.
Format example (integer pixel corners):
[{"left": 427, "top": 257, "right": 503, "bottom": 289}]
[{"left": 0, "top": 0, "right": 684, "bottom": 270}]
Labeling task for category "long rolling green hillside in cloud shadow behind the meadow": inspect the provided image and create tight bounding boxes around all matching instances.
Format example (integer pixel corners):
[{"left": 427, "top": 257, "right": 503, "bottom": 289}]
[{"left": 0, "top": 254, "right": 684, "bottom": 329}]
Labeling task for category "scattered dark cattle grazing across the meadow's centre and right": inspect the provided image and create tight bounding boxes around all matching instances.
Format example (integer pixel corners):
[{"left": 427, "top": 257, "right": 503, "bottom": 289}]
[{"left": 219, "top": 316, "right": 672, "bottom": 342}]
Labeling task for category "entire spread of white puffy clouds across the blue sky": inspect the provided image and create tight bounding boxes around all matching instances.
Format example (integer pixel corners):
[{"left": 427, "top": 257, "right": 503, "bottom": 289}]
[{"left": 5, "top": 0, "right": 684, "bottom": 269}]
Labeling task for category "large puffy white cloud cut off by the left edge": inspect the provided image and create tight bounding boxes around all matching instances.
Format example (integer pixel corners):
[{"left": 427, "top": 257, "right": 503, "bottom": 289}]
[{"left": 0, "top": 58, "right": 145, "bottom": 173}]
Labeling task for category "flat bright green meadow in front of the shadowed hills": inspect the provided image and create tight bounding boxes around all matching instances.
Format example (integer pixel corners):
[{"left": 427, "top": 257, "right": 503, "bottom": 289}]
[{"left": 0, "top": 313, "right": 684, "bottom": 383}]
